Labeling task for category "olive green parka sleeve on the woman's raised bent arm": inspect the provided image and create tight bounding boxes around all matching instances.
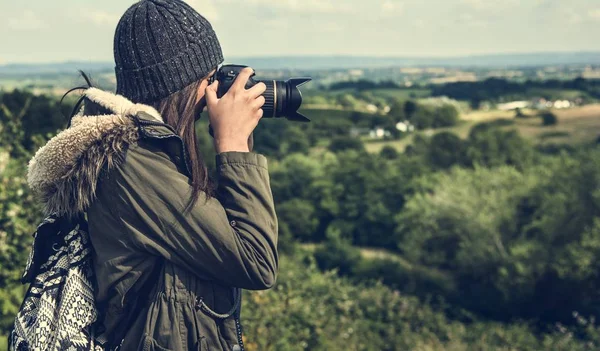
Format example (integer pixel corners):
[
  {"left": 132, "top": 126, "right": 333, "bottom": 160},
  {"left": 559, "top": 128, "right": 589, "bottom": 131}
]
[{"left": 113, "top": 141, "right": 278, "bottom": 290}]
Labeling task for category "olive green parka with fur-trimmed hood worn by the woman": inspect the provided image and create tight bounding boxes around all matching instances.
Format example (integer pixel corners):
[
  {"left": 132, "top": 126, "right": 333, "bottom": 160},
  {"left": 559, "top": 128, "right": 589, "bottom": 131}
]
[{"left": 28, "top": 88, "right": 278, "bottom": 351}]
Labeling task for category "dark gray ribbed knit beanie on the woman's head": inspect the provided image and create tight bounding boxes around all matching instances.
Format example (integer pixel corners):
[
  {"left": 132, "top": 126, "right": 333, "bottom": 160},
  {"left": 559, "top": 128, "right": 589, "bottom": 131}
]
[{"left": 114, "top": 0, "right": 223, "bottom": 103}]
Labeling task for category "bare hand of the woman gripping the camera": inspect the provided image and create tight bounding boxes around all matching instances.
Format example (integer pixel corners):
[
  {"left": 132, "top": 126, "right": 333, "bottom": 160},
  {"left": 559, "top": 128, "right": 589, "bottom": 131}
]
[{"left": 205, "top": 67, "right": 267, "bottom": 154}]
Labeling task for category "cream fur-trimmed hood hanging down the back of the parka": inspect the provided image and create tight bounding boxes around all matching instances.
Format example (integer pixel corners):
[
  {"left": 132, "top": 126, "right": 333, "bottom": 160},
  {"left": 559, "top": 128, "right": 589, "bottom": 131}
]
[{"left": 27, "top": 88, "right": 163, "bottom": 216}]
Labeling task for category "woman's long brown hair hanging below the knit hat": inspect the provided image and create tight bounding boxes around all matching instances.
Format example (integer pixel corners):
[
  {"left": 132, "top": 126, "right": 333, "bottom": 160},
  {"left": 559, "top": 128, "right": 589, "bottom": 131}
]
[{"left": 150, "top": 79, "right": 214, "bottom": 212}]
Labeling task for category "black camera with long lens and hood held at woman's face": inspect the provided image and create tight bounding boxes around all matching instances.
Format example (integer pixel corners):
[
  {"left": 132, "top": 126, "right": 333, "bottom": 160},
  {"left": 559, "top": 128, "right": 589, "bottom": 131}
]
[{"left": 210, "top": 65, "right": 312, "bottom": 122}]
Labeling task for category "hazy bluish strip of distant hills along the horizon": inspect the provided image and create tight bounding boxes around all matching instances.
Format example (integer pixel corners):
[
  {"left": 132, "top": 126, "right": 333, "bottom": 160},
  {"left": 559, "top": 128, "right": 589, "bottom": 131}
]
[{"left": 0, "top": 52, "right": 600, "bottom": 76}]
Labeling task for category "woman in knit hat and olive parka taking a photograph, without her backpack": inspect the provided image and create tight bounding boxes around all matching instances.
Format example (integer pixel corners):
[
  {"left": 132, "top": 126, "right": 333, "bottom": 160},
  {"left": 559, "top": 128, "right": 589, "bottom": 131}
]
[{"left": 29, "top": 0, "right": 278, "bottom": 350}]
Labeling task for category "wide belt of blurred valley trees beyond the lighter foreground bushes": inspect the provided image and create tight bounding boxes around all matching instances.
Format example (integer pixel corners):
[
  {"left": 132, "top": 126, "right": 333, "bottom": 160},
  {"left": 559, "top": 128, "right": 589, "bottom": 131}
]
[{"left": 258, "top": 115, "right": 600, "bottom": 336}]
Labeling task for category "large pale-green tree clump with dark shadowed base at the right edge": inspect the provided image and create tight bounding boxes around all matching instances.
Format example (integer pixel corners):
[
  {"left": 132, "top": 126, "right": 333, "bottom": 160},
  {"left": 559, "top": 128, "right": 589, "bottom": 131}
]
[{"left": 396, "top": 155, "right": 600, "bottom": 321}]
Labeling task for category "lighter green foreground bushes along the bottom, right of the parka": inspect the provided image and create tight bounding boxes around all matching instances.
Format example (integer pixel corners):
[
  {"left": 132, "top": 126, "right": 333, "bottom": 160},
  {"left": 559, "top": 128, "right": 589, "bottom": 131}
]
[{"left": 242, "top": 255, "right": 600, "bottom": 351}]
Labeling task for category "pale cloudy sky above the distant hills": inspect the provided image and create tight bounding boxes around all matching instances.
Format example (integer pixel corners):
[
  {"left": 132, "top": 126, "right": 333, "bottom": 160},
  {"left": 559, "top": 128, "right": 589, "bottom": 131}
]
[{"left": 0, "top": 0, "right": 600, "bottom": 64}]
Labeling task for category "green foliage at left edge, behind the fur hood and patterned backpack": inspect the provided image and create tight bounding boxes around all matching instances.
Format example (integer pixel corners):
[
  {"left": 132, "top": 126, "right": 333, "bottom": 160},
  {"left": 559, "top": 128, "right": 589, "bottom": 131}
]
[{"left": 0, "top": 91, "right": 62, "bottom": 333}]
